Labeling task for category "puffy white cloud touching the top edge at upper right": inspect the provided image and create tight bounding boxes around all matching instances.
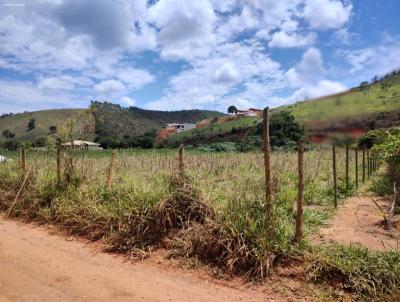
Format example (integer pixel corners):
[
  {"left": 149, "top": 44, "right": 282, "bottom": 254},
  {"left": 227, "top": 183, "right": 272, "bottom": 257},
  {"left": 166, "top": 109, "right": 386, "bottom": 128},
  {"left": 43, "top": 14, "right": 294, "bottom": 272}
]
[{"left": 304, "top": 0, "right": 353, "bottom": 29}]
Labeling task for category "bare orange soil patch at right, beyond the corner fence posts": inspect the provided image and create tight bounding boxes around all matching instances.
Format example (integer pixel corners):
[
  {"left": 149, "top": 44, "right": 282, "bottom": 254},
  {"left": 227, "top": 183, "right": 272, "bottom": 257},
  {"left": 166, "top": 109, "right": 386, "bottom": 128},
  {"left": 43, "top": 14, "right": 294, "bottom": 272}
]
[{"left": 312, "top": 195, "right": 400, "bottom": 251}]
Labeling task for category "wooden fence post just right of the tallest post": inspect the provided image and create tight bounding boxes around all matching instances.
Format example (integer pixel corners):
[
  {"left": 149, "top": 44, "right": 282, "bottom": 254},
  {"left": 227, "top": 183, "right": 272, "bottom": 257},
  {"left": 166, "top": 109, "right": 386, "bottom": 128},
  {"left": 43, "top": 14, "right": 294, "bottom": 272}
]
[{"left": 294, "top": 141, "right": 304, "bottom": 243}]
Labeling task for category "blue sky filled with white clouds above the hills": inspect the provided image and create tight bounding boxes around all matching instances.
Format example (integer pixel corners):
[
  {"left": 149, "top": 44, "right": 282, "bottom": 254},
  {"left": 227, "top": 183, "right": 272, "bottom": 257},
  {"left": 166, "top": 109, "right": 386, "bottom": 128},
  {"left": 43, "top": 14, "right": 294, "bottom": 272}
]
[{"left": 0, "top": 0, "right": 400, "bottom": 113}]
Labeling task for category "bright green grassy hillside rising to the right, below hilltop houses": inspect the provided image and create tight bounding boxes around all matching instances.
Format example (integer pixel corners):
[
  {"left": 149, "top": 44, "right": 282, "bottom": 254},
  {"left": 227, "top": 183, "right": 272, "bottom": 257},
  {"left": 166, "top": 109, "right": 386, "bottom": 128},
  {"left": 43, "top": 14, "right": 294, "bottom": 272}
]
[{"left": 164, "top": 72, "right": 400, "bottom": 146}]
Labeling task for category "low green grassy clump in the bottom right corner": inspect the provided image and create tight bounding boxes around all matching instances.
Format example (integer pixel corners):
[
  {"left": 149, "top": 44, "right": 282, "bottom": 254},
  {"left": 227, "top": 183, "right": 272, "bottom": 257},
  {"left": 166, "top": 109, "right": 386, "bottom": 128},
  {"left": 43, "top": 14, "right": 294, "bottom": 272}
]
[{"left": 308, "top": 245, "right": 400, "bottom": 297}]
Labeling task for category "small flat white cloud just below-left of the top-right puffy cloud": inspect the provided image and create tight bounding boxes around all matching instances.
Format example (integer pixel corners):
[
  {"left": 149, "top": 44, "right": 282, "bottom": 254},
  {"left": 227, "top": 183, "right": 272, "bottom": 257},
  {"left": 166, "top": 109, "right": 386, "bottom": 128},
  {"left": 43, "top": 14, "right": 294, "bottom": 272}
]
[{"left": 268, "top": 31, "right": 317, "bottom": 48}]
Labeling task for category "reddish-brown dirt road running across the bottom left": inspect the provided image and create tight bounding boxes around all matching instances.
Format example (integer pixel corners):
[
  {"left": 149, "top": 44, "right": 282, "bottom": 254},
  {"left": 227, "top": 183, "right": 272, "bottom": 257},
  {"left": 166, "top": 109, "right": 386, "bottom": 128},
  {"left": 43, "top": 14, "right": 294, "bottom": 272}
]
[{"left": 0, "top": 216, "right": 281, "bottom": 302}]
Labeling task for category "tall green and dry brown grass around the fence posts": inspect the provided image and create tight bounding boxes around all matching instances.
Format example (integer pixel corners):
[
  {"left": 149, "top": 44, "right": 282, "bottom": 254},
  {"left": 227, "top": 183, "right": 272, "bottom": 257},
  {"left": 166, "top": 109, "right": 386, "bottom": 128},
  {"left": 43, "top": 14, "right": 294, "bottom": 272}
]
[{"left": 0, "top": 148, "right": 400, "bottom": 296}]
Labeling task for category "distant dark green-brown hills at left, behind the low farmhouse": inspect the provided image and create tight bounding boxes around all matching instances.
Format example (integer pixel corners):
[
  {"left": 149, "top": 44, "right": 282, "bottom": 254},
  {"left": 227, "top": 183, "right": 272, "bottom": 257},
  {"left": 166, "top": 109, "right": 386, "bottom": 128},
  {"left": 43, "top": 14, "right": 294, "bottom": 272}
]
[{"left": 0, "top": 102, "right": 224, "bottom": 142}]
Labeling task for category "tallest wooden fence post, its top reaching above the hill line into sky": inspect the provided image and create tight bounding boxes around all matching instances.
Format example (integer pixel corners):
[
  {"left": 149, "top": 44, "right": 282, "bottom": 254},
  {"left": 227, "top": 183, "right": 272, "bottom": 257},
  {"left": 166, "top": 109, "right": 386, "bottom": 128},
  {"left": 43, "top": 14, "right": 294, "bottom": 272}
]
[{"left": 263, "top": 107, "right": 272, "bottom": 219}]
